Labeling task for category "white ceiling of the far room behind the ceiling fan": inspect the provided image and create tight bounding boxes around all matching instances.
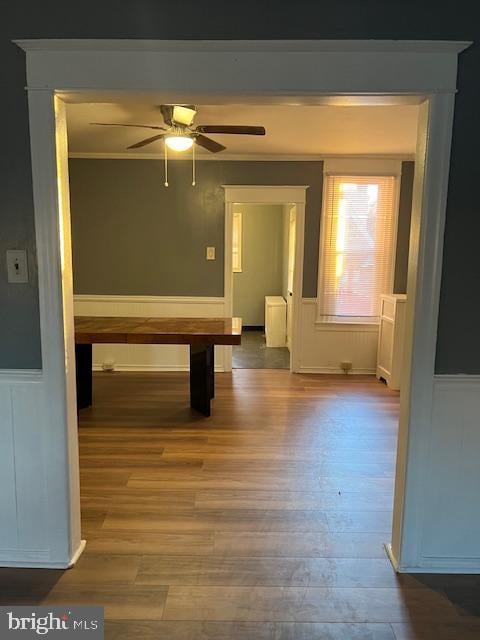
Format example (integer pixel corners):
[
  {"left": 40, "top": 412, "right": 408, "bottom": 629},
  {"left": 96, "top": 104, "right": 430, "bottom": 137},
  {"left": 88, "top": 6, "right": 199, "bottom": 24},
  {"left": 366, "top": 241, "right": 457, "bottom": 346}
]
[{"left": 67, "top": 102, "right": 418, "bottom": 159}]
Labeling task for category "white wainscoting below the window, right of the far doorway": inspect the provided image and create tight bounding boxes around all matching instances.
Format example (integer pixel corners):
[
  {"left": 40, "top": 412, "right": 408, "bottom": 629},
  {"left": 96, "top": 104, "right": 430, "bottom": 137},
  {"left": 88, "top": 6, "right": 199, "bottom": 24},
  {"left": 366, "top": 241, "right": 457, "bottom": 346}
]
[{"left": 298, "top": 298, "right": 378, "bottom": 374}]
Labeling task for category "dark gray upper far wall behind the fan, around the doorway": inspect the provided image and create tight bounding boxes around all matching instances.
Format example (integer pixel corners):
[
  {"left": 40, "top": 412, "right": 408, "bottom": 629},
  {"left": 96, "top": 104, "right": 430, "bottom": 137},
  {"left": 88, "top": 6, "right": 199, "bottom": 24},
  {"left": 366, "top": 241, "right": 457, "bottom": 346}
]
[{"left": 69, "top": 159, "right": 323, "bottom": 297}]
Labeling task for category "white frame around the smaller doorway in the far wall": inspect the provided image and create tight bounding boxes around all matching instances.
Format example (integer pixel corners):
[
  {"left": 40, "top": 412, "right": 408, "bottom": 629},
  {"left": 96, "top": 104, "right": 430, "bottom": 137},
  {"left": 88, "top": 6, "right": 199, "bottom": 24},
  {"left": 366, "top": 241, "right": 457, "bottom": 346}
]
[{"left": 223, "top": 185, "right": 308, "bottom": 372}]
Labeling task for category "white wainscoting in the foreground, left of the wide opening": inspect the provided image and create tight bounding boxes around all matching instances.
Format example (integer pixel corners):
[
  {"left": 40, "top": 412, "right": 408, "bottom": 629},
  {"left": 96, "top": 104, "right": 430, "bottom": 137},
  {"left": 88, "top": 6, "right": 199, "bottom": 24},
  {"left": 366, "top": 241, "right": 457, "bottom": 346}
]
[{"left": 0, "top": 371, "right": 50, "bottom": 566}]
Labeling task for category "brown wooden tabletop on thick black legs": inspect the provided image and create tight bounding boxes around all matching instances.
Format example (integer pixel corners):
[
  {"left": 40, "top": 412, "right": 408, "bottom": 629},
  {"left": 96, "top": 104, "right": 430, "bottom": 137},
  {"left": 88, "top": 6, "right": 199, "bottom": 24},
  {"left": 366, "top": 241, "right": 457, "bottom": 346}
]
[{"left": 75, "top": 316, "right": 242, "bottom": 345}]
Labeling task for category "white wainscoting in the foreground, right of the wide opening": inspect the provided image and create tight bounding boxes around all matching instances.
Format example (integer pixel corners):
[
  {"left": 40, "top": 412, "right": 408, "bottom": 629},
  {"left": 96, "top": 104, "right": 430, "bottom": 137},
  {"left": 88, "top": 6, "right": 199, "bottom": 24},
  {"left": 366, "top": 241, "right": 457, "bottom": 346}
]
[{"left": 417, "top": 375, "right": 480, "bottom": 573}]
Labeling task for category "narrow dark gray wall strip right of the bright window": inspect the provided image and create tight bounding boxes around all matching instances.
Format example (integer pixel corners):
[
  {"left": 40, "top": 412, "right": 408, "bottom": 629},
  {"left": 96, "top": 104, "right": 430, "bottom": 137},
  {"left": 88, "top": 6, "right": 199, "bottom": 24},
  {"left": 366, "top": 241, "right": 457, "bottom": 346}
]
[{"left": 393, "top": 162, "right": 415, "bottom": 293}]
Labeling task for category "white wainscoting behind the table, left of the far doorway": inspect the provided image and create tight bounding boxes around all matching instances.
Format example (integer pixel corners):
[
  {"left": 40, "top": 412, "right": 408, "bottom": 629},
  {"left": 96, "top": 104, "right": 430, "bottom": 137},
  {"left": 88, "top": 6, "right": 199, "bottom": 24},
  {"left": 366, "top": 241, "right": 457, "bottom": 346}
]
[{"left": 74, "top": 295, "right": 225, "bottom": 371}]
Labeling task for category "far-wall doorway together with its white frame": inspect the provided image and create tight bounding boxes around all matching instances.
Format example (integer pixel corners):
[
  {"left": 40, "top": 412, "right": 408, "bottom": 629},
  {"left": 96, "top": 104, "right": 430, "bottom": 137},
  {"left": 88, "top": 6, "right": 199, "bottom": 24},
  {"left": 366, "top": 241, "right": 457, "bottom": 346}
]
[{"left": 224, "top": 185, "right": 308, "bottom": 372}]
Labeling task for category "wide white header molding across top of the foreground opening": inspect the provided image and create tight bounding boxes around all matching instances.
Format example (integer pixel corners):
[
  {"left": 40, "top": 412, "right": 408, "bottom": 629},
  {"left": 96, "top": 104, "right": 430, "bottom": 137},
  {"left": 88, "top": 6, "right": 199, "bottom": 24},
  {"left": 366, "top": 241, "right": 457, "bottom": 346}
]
[{"left": 16, "top": 39, "right": 471, "bottom": 97}]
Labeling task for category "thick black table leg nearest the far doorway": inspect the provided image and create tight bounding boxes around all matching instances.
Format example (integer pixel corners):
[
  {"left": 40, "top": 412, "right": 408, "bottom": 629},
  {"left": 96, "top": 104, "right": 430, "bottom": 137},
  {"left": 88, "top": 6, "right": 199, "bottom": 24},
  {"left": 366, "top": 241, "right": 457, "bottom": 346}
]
[{"left": 190, "top": 344, "right": 215, "bottom": 416}]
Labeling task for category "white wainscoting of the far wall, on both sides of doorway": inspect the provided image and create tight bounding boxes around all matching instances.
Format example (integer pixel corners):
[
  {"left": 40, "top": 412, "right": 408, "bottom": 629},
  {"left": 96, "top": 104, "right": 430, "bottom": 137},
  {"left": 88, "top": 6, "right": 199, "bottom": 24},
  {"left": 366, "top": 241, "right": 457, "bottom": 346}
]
[{"left": 74, "top": 295, "right": 378, "bottom": 373}]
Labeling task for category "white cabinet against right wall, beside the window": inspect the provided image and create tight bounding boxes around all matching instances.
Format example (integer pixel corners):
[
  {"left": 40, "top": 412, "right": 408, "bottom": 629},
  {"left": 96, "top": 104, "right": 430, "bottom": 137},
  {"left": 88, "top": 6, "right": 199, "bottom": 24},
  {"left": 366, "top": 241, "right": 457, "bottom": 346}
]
[{"left": 377, "top": 293, "right": 407, "bottom": 390}]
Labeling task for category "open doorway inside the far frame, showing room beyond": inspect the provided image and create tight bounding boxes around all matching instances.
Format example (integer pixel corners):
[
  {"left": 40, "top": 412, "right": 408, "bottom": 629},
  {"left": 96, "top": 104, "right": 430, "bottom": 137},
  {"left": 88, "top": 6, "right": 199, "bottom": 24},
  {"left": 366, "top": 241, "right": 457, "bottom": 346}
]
[{"left": 232, "top": 203, "right": 296, "bottom": 369}]
